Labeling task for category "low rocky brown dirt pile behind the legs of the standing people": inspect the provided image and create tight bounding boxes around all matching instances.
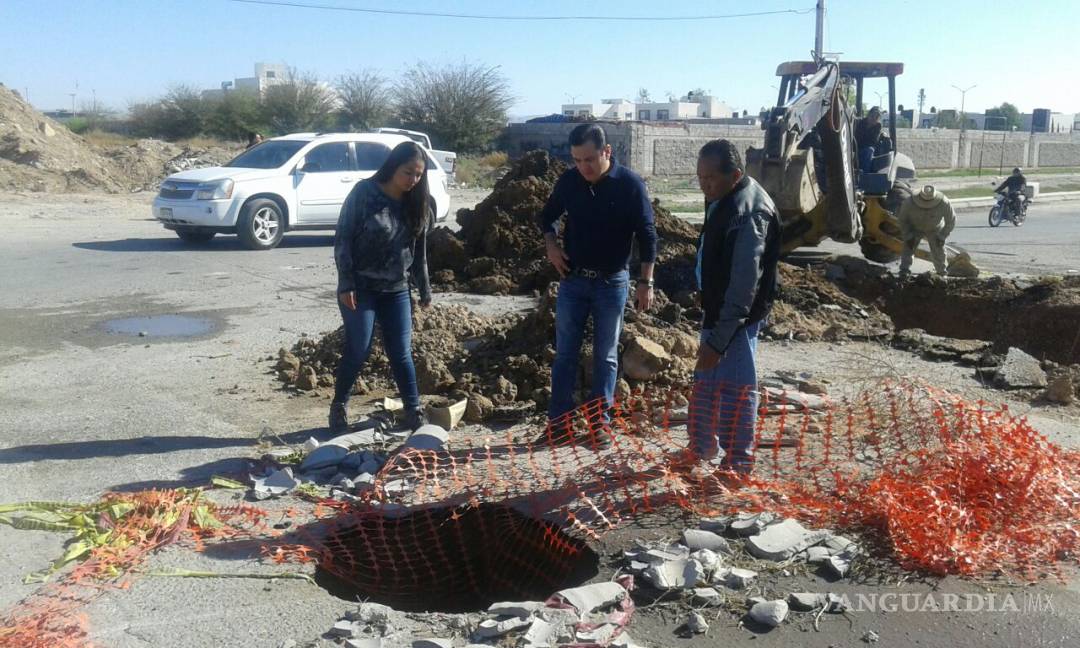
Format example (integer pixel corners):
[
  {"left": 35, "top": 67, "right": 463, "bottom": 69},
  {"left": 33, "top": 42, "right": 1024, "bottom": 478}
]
[{"left": 275, "top": 291, "right": 697, "bottom": 421}]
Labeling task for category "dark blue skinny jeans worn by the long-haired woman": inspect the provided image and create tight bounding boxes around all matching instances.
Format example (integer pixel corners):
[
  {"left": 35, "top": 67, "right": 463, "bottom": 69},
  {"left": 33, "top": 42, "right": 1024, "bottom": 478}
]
[{"left": 334, "top": 289, "right": 420, "bottom": 410}]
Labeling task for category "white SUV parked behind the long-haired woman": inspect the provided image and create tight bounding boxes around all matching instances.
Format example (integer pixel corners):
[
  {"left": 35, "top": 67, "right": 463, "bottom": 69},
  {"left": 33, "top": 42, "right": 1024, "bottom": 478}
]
[{"left": 153, "top": 133, "right": 450, "bottom": 249}]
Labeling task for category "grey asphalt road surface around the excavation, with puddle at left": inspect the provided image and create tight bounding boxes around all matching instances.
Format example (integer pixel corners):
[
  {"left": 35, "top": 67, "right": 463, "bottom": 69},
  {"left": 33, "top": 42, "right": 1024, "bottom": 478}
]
[{"left": 6, "top": 194, "right": 1080, "bottom": 648}]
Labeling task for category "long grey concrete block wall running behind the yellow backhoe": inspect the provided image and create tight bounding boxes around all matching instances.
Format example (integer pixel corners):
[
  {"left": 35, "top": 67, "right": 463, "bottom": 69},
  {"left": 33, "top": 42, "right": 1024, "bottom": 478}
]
[{"left": 502, "top": 122, "right": 1080, "bottom": 177}]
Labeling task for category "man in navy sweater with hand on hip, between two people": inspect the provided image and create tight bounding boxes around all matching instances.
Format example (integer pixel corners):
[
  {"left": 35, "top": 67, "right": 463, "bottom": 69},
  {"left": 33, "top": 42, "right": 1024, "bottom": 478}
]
[{"left": 540, "top": 123, "right": 657, "bottom": 440}]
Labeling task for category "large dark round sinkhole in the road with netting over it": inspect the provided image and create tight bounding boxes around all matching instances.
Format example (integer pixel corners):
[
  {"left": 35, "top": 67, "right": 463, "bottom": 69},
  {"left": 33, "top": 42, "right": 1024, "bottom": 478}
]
[{"left": 315, "top": 503, "right": 599, "bottom": 613}]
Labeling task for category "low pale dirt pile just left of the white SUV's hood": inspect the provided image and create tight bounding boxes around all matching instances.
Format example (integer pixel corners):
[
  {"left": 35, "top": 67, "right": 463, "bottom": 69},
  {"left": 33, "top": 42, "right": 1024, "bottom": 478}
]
[{"left": 103, "top": 139, "right": 241, "bottom": 191}]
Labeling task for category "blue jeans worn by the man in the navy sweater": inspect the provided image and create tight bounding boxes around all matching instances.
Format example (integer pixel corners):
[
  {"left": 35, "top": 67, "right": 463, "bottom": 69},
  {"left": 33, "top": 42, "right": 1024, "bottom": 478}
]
[{"left": 548, "top": 270, "right": 630, "bottom": 419}]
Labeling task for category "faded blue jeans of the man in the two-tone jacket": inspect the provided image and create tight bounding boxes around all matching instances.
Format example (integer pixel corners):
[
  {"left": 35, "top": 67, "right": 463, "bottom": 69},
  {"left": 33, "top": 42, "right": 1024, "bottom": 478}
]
[{"left": 689, "top": 322, "right": 761, "bottom": 473}]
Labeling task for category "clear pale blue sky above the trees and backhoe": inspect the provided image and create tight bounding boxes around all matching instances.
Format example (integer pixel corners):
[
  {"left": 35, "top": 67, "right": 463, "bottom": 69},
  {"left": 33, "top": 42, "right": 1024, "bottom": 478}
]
[{"left": 0, "top": 0, "right": 1080, "bottom": 116}]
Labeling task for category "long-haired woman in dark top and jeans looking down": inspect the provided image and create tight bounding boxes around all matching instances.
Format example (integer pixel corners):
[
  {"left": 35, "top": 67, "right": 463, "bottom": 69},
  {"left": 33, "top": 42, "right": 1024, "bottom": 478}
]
[{"left": 329, "top": 141, "right": 432, "bottom": 434}]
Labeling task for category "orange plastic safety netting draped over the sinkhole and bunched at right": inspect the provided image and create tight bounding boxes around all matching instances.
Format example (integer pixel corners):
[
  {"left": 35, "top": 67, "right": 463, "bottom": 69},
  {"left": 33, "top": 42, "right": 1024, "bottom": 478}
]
[{"left": 287, "top": 382, "right": 1080, "bottom": 609}]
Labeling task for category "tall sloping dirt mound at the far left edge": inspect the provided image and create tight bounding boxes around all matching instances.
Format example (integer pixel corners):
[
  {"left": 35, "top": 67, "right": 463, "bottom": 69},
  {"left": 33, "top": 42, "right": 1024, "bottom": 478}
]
[{"left": 0, "top": 85, "right": 127, "bottom": 192}]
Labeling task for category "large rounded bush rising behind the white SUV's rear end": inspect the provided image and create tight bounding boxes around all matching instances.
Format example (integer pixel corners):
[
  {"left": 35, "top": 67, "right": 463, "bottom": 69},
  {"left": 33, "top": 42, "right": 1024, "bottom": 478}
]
[{"left": 393, "top": 63, "right": 514, "bottom": 152}]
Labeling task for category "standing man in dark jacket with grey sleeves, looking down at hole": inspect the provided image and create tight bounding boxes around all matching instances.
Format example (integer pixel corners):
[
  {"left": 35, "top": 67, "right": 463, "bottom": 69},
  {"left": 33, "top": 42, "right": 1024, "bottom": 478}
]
[{"left": 689, "top": 139, "right": 781, "bottom": 474}]
